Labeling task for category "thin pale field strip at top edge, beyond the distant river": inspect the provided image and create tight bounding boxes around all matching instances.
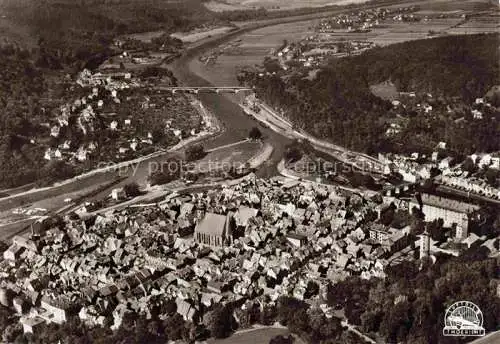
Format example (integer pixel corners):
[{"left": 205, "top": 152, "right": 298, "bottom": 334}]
[{"left": 205, "top": 0, "right": 367, "bottom": 12}]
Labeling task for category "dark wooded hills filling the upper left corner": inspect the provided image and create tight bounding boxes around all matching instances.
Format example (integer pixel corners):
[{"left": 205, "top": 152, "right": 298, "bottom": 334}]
[{"left": 0, "top": 0, "right": 217, "bottom": 68}]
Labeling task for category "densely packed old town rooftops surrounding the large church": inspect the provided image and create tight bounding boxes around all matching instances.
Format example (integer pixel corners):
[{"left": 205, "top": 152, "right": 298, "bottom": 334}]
[{"left": 0, "top": 175, "right": 438, "bottom": 332}]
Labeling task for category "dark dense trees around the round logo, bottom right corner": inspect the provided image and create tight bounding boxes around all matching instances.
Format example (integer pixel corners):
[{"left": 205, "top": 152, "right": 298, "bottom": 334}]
[{"left": 328, "top": 251, "right": 500, "bottom": 344}]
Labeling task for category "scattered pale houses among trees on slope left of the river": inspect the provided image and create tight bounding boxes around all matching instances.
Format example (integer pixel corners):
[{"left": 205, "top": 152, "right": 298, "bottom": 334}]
[{"left": 40, "top": 69, "right": 207, "bottom": 168}]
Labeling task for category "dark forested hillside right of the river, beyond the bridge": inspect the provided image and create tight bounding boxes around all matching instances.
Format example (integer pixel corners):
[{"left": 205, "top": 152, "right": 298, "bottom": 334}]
[{"left": 239, "top": 34, "right": 500, "bottom": 153}]
